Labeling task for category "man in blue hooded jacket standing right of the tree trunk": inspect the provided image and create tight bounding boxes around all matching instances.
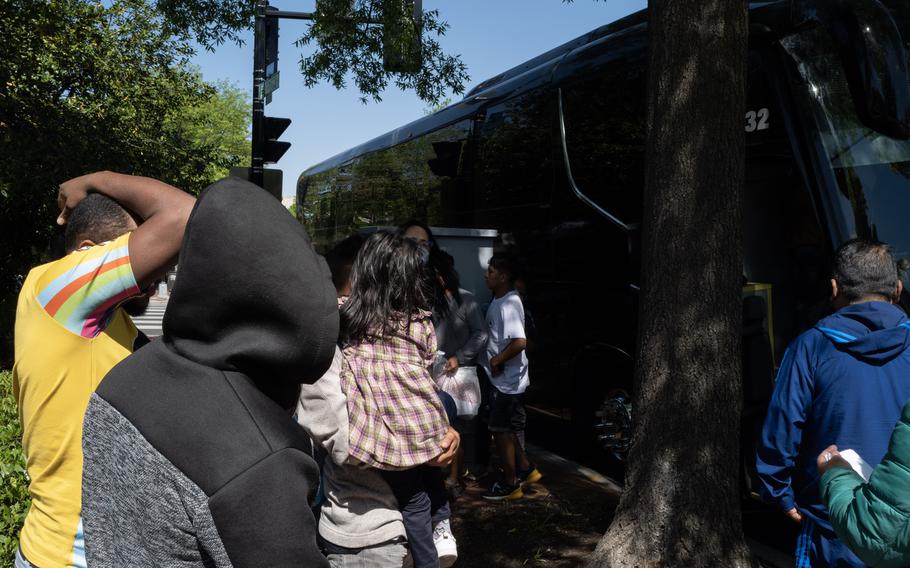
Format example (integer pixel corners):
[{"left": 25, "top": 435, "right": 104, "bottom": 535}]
[{"left": 757, "top": 240, "right": 910, "bottom": 567}]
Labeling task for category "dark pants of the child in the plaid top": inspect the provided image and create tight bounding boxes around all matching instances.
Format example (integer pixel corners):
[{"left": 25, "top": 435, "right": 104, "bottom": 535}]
[{"left": 382, "top": 465, "right": 451, "bottom": 568}]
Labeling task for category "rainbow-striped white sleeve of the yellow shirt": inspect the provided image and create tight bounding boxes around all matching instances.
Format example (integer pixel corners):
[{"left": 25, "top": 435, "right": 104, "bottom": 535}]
[{"left": 38, "top": 233, "right": 140, "bottom": 338}]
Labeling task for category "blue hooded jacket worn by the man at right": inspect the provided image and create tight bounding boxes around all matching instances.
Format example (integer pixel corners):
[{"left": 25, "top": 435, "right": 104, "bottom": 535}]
[{"left": 757, "top": 302, "right": 910, "bottom": 536}]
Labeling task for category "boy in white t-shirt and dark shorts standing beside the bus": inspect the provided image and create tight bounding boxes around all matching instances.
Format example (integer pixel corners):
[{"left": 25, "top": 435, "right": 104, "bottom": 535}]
[{"left": 480, "top": 255, "right": 541, "bottom": 501}]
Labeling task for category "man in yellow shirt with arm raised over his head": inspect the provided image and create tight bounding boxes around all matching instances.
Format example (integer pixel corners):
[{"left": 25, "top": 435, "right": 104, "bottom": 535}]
[{"left": 13, "top": 172, "right": 195, "bottom": 568}]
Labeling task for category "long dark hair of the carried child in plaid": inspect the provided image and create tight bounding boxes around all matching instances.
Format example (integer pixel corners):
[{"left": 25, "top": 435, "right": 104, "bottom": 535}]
[{"left": 341, "top": 231, "right": 433, "bottom": 344}]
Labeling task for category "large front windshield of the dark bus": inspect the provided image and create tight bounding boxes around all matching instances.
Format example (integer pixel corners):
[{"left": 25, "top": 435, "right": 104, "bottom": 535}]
[{"left": 781, "top": 1, "right": 910, "bottom": 270}]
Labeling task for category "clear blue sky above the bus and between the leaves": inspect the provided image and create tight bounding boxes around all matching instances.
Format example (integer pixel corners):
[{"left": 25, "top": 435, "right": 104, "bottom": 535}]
[{"left": 194, "top": 0, "right": 646, "bottom": 195}]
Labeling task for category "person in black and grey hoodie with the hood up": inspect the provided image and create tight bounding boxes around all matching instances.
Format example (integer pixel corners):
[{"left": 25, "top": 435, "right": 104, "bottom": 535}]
[{"left": 82, "top": 178, "right": 338, "bottom": 568}]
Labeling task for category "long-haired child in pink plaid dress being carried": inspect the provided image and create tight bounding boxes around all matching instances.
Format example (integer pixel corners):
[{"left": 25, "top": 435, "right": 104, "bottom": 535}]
[{"left": 341, "top": 231, "right": 449, "bottom": 568}]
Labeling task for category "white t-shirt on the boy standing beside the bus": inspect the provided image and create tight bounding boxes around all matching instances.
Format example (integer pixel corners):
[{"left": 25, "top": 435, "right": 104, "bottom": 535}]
[{"left": 481, "top": 290, "right": 530, "bottom": 394}]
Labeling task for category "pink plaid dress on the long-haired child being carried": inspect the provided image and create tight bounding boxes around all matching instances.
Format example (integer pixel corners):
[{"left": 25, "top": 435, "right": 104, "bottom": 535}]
[{"left": 341, "top": 312, "right": 449, "bottom": 470}]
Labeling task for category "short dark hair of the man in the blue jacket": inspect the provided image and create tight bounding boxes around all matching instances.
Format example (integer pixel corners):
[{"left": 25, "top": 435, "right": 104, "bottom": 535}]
[{"left": 831, "top": 239, "right": 898, "bottom": 302}]
